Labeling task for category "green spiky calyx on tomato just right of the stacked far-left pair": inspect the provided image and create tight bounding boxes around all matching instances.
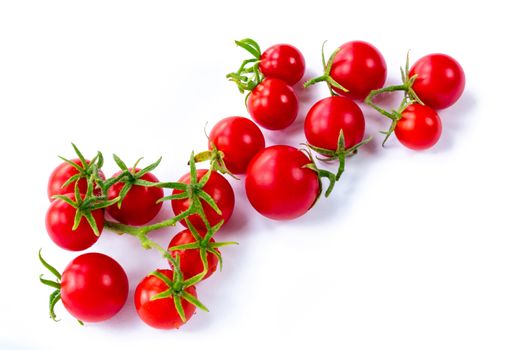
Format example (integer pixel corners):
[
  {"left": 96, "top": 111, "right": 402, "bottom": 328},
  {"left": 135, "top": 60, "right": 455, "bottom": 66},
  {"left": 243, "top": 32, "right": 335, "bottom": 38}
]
[{"left": 104, "top": 154, "right": 162, "bottom": 209}]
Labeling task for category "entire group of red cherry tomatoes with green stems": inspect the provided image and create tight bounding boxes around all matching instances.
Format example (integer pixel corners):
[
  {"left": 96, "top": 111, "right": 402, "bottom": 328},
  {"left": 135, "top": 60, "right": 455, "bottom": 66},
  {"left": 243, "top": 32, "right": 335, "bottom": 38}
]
[{"left": 39, "top": 39, "right": 465, "bottom": 329}]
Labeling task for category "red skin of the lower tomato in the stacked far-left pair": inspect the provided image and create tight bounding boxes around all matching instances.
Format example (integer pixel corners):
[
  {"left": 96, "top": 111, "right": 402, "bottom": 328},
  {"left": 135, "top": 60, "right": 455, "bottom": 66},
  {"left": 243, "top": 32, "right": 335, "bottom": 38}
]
[{"left": 46, "top": 193, "right": 104, "bottom": 251}]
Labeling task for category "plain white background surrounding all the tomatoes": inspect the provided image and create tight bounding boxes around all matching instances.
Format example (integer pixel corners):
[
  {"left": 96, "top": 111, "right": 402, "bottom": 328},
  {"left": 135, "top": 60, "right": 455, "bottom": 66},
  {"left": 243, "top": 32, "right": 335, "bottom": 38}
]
[{"left": 0, "top": 1, "right": 525, "bottom": 350}]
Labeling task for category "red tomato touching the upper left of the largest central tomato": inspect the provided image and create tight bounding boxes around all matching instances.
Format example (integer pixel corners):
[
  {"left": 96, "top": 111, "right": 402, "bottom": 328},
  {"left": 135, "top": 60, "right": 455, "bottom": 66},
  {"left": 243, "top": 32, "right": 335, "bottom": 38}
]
[{"left": 209, "top": 117, "right": 265, "bottom": 174}]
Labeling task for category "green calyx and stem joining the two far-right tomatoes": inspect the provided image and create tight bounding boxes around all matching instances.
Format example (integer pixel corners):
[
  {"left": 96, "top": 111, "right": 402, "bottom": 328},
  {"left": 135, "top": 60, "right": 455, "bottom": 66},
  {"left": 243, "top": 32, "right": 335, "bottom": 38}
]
[{"left": 365, "top": 51, "right": 425, "bottom": 147}]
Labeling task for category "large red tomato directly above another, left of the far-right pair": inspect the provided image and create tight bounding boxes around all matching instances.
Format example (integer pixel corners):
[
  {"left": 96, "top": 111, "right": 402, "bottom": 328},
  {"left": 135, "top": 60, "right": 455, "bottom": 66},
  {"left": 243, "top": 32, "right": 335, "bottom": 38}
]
[{"left": 330, "top": 41, "right": 386, "bottom": 101}]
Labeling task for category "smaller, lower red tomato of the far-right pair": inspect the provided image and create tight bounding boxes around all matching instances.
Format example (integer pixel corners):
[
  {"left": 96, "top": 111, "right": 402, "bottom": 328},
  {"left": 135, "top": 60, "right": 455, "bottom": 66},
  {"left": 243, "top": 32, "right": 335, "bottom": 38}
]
[{"left": 394, "top": 103, "right": 441, "bottom": 150}]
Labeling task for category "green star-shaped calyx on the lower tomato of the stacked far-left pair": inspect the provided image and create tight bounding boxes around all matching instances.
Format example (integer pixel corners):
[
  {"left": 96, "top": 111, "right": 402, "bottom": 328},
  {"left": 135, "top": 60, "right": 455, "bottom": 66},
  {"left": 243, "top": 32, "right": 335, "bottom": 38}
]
[{"left": 53, "top": 178, "right": 120, "bottom": 236}]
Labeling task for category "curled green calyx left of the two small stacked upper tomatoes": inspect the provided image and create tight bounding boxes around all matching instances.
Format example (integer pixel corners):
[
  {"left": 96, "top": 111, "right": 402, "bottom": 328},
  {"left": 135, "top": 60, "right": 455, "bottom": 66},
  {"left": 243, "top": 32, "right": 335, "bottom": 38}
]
[{"left": 226, "top": 38, "right": 264, "bottom": 94}]
